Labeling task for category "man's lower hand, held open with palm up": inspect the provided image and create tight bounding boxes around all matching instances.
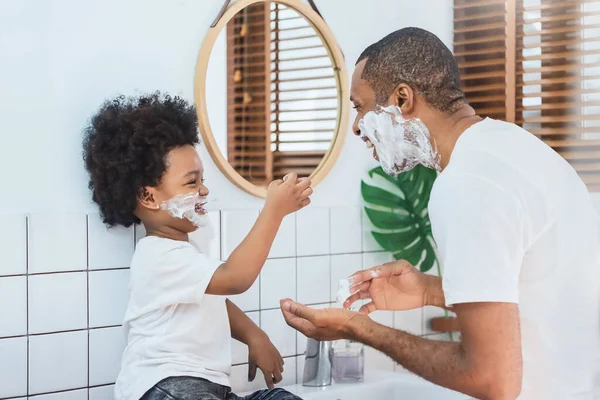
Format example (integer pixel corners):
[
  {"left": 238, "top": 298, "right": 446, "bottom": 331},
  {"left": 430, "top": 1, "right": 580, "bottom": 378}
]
[{"left": 280, "top": 299, "right": 369, "bottom": 341}]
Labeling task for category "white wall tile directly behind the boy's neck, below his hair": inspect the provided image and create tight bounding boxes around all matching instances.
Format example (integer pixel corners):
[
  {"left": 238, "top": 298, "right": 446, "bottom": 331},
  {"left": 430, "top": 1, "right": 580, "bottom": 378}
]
[{"left": 88, "top": 214, "right": 135, "bottom": 269}]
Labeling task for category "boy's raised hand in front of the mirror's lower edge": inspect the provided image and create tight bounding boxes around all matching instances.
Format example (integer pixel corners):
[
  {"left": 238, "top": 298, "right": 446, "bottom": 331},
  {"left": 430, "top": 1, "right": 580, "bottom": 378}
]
[{"left": 265, "top": 172, "right": 313, "bottom": 218}]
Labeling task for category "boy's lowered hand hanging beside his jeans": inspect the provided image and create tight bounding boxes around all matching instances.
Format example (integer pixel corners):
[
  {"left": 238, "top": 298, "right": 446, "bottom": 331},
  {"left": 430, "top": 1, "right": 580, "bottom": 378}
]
[{"left": 248, "top": 335, "right": 284, "bottom": 389}]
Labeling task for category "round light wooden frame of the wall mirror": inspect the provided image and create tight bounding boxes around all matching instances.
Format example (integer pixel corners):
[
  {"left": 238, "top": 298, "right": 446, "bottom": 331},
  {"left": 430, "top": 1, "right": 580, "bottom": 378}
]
[{"left": 194, "top": 0, "right": 350, "bottom": 198}]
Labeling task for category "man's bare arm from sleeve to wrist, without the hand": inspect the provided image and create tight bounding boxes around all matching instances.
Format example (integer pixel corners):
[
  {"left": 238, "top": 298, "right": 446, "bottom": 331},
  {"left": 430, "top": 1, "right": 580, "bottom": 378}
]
[{"left": 350, "top": 303, "right": 522, "bottom": 400}]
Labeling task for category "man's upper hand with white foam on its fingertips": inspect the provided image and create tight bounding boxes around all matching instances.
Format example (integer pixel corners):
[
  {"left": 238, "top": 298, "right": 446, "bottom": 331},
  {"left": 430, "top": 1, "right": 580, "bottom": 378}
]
[{"left": 344, "top": 261, "right": 444, "bottom": 314}]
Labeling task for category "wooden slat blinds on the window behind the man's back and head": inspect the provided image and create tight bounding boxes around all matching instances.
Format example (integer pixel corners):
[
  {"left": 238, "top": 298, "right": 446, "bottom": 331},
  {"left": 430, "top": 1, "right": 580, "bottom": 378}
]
[{"left": 454, "top": 0, "right": 600, "bottom": 190}]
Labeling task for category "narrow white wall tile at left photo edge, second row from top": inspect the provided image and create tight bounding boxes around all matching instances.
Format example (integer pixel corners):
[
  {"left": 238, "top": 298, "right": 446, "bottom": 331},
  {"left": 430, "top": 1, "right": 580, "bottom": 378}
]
[{"left": 0, "top": 276, "right": 27, "bottom": 337}]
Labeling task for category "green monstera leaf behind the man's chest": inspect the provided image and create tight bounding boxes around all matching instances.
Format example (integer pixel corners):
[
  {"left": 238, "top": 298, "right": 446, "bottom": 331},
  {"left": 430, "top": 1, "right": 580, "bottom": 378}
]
[{"left": 361, "top": 165, "right": 437, "bottom": 272}]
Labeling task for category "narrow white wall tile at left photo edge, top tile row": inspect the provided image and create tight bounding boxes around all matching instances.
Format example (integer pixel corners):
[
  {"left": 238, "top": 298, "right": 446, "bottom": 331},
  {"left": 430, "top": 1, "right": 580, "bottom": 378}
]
[{"left": 0, "top": 215, "right": 27, "bottom": 275}]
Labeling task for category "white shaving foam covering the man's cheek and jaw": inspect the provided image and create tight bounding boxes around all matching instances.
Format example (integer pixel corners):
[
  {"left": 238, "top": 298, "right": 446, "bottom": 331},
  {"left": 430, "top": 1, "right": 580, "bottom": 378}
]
[{"left": 358, "top": 105, "right": 441, "bottom": 175}]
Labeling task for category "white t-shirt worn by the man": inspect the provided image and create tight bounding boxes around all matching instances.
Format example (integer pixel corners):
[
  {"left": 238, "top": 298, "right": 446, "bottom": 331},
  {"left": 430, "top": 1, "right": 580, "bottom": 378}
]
[{"left": 429, "top": 119, "right": 600, "bottom": 400}]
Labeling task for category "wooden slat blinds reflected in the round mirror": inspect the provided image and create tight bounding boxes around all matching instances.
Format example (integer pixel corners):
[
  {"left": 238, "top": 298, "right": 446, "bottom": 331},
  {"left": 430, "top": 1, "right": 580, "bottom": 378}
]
[{"left": 227, "top": 1, "right": 338, "bottom": 184}]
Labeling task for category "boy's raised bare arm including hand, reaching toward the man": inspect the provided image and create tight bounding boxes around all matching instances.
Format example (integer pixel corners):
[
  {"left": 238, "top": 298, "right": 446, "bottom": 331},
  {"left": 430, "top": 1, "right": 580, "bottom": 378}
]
[{"left": 206, "top": 173, "right": 312, "bottom": 296}]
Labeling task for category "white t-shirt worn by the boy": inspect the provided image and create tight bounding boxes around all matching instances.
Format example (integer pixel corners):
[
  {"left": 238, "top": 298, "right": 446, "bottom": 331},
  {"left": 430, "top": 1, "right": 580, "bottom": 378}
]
[{"left": 115, "top": 237, "right": 231, "bottom": 400}]
